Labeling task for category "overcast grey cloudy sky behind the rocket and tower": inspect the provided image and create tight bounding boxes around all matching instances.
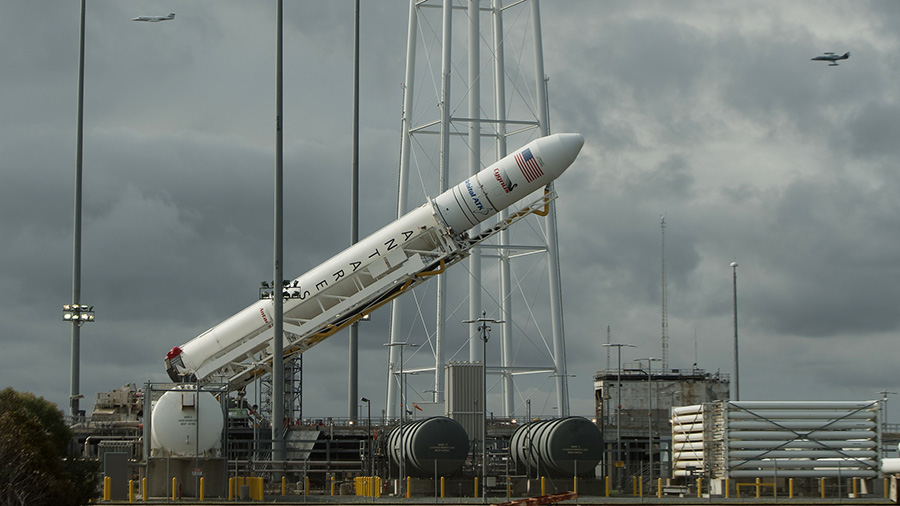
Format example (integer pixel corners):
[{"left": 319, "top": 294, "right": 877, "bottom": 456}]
[{"left": 0, "top": 0, "right": 900, "bottom": 422}]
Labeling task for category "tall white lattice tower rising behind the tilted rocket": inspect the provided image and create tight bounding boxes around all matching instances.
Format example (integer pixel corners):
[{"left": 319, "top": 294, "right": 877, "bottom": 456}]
[{"left": 386, "top": 0, "right": 569, "bottom": 416}]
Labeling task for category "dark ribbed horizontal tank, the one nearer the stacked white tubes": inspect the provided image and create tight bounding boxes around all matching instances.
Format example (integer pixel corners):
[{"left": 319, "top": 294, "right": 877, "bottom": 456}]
[{"left": 509, "top": 416, "right": 603, "bottom": 476}]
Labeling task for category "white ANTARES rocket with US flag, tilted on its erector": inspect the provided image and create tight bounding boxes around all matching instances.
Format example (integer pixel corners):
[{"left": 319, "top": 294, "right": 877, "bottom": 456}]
[{"left": 166, "top": 134, "right": 584, "bottom": 388}]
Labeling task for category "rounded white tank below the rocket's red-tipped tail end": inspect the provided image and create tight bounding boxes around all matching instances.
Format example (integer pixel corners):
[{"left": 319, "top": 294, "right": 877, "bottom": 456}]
[{"left": 150, "top": 385, "right": 225, "bottom": 457}]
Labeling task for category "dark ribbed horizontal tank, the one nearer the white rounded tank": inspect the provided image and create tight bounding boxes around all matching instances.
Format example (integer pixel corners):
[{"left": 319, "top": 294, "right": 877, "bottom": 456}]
[{"left": 388, "top": 416, "right": 469, "bottom": 477}]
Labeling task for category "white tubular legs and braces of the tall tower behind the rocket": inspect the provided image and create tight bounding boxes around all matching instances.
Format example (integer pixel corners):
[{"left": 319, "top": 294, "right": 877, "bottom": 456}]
[{"left": 386, "top": 0, "right": 569, "bottom": 422}]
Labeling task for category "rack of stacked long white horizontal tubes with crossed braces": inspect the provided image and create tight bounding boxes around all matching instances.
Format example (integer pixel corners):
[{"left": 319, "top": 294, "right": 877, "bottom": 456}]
[{"left": 672, "top": 401, "right": 881, "bottom": 479}]
